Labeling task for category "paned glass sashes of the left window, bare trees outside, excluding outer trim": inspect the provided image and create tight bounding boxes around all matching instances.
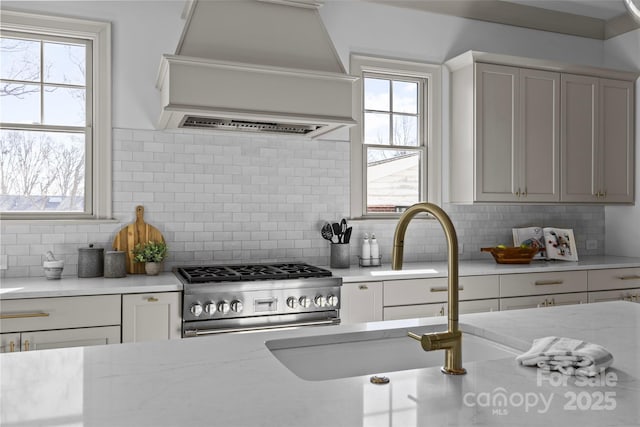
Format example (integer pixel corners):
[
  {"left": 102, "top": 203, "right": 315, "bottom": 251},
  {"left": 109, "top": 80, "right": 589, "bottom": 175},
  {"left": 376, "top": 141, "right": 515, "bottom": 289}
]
[{"left": 0, "top": 33, "right": 88, "bottom": 212}]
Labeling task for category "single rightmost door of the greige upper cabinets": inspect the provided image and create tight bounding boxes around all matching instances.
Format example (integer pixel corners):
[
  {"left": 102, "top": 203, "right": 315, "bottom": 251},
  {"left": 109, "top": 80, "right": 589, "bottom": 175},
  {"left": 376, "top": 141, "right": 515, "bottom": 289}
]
[{"left": 598, "top": 79, "right": 634, "bottom": 203}]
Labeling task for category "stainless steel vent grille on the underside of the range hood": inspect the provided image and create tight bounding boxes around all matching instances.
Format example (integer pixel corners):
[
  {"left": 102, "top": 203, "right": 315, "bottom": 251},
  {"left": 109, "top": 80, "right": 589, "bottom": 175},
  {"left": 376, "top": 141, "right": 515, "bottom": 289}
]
[{"left": 180, "top": 116, "right": 322, "bottom": 135}]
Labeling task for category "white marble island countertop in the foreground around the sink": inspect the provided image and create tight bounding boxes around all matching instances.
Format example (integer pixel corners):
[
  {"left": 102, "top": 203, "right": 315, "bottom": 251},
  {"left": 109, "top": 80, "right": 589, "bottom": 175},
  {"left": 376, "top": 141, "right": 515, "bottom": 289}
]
[{"left": 0, "top": 302, "right": 640, "bottom": 427}]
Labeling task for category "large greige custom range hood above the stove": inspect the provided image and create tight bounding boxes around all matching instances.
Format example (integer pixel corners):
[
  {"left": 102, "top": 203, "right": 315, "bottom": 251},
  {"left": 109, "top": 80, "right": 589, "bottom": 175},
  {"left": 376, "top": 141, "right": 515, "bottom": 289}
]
[{"left": 156, "top": 0, "right": 356, "bottom": 138}]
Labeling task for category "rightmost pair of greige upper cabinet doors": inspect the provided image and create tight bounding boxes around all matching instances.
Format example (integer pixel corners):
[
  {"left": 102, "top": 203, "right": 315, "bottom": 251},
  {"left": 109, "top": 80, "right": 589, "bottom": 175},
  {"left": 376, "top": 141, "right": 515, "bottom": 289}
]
[{"left": 561, "top": 74, "right": 634, "bottom": 203}]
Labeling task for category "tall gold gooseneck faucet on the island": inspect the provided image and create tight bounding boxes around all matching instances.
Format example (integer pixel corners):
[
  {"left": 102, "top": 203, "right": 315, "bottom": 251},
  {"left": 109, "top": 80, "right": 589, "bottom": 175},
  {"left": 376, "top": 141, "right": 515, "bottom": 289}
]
[{"left": 391, "top": 202, "right": 467, "bottom": 375}]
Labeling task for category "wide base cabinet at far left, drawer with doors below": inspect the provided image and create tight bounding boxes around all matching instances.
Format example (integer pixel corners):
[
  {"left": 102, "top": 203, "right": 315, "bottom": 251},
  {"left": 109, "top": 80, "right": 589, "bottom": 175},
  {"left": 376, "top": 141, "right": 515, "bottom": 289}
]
[{"left": 0, "top": 295, "right": 121, "bottom": 352}]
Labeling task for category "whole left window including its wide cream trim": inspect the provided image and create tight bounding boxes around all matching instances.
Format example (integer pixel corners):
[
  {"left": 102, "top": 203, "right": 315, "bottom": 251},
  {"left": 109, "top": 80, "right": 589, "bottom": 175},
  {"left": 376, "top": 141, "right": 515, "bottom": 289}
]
[{"left": 0, "top": 11, "right": 111, "bottom": 219}]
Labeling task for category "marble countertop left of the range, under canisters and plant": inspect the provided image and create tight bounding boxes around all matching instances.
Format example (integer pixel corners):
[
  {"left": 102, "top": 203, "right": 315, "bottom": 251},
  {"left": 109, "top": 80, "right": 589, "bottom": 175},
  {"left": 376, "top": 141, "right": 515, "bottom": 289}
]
[{"left": 0, "top": 273, "right": 182, "bottom": 300}]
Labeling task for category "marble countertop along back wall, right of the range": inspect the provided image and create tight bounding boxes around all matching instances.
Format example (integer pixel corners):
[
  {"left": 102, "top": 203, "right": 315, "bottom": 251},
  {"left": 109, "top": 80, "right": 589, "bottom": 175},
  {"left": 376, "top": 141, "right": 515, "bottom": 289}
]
[{"left": 331, "top": 254, "right": 640, "bottom": 283}]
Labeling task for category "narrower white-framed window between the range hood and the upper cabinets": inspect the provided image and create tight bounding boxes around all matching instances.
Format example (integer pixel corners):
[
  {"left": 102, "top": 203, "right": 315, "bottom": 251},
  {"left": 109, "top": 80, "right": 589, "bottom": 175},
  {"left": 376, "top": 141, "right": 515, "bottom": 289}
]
[{"left": 351, "top": 55, "right": 440, "bottom": 218}]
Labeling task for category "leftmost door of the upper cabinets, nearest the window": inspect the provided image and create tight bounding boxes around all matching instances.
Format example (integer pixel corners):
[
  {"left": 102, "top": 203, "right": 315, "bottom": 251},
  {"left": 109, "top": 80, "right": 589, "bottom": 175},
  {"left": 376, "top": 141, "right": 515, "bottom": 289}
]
[{"left": 475, "top": 64, "right": 521, "bottom": 202}]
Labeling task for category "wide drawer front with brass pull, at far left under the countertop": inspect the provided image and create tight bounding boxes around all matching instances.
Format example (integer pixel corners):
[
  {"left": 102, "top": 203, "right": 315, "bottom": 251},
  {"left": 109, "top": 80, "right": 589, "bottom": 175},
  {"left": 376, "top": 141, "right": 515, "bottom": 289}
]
[{"left": 0, "top": 295, "right": 121, "bottom": 332}]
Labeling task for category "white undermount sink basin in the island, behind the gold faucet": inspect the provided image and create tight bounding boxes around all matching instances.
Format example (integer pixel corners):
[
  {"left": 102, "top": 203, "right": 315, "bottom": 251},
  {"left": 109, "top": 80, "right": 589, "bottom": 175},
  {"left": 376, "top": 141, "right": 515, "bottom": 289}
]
[{"left": 265, "top": 325, "right": 519, "bottom": 381}]
